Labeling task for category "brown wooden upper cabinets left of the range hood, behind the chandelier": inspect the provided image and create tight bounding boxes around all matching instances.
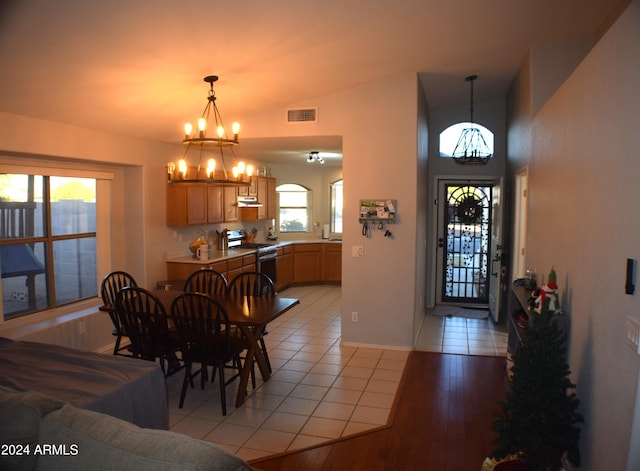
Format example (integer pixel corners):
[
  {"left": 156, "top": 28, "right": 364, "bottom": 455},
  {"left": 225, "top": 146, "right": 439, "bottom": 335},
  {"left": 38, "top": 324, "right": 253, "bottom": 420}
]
[{"left": 166, "top": 183, "right": 238, "bottom": 227}]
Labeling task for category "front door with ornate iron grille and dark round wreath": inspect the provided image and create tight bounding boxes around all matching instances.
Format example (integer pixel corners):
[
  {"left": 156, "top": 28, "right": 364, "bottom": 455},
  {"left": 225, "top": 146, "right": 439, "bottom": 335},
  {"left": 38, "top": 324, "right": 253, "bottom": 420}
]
[{"left": 436, "top": 180, "right": 493, "bottom": 307}]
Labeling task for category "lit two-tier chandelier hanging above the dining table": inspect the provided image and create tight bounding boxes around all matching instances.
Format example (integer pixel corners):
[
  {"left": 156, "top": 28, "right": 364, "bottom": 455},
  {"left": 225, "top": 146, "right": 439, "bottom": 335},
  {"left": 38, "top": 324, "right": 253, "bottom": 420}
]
[{"left": 167, "top": 75, "right": 254, "bottom": 186}]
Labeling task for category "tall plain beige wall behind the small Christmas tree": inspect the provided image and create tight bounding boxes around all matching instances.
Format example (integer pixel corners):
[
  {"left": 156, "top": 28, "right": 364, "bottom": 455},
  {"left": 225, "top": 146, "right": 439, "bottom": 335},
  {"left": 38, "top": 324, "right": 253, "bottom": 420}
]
[{"left": 509, "top": 0, "right": 640, "bottom": 471}]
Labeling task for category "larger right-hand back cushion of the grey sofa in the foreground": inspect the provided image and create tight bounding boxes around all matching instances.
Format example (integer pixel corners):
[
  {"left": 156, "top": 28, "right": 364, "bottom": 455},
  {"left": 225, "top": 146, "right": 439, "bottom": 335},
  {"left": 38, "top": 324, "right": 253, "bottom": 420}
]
[{"left": 37, "top": 404, "right": 252, "bottom": 471}]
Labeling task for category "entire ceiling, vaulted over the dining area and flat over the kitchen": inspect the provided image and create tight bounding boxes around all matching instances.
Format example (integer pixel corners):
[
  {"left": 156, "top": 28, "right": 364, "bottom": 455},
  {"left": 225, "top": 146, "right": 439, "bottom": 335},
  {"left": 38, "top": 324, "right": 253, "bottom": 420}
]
[{"left": 0, "top": 0, "right": 626, "bottom": 167}]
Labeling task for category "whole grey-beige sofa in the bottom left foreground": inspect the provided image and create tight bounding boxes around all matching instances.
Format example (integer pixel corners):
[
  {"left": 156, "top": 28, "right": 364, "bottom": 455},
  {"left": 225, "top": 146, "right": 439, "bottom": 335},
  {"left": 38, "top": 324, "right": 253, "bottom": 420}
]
[{"left": 0, "top": 386, "right": 252, "bottom": 471}]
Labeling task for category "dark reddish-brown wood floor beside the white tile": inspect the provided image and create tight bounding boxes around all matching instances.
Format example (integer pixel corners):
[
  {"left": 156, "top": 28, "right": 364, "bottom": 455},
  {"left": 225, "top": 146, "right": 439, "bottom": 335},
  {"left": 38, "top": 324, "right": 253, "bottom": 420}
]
[{"left": 251, "top": 352, "right": 505, "bottom": 471}]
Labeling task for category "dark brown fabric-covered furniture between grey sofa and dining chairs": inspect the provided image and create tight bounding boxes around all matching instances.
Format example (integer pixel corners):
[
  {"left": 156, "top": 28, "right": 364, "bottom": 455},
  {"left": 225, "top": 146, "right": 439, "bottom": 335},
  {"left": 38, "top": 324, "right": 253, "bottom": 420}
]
[{"left": 0, "top": 337, "right": 169, "bottom": 429}]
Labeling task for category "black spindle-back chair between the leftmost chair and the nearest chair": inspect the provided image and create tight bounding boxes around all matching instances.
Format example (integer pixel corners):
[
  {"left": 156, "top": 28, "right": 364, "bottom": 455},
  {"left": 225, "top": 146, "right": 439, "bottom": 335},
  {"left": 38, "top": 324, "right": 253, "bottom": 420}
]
[{"left": 116, "top": 286, "right": 181, "bottom": 376}]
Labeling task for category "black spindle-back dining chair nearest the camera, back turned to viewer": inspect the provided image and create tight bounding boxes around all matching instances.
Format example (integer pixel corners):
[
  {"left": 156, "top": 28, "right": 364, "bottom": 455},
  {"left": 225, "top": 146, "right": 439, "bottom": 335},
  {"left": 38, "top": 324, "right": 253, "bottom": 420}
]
[{"left": 171, "top": 293, "right": 245, "bottom": 415}]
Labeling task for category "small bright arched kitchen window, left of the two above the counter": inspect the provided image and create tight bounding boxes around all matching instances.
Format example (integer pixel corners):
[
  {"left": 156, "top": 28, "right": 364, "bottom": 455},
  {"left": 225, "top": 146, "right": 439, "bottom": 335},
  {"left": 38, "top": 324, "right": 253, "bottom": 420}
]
[{"left": 276, "top": 183, "right": 311, "bottom": 232}]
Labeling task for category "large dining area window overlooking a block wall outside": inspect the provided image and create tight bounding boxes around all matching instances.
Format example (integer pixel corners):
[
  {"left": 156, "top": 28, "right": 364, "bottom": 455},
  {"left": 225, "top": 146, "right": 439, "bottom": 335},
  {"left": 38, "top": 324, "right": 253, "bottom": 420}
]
[{"left": 0, "top": 167, "right": 109, "bottom": 322}]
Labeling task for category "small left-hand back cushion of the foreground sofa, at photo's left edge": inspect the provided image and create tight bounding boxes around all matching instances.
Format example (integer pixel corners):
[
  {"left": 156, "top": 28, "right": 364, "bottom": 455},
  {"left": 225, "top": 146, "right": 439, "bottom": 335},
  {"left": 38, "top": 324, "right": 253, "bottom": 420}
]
[{"left": 0, "top": 387, "right": 64, "bottom": 471}]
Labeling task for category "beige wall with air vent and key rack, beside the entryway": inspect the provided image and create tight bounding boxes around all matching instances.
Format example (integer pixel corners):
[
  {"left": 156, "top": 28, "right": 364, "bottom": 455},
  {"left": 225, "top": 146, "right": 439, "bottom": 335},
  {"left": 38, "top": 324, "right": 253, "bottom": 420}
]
[{"left": 242, "top": 74, "right": 426, "bottom": 348}]
